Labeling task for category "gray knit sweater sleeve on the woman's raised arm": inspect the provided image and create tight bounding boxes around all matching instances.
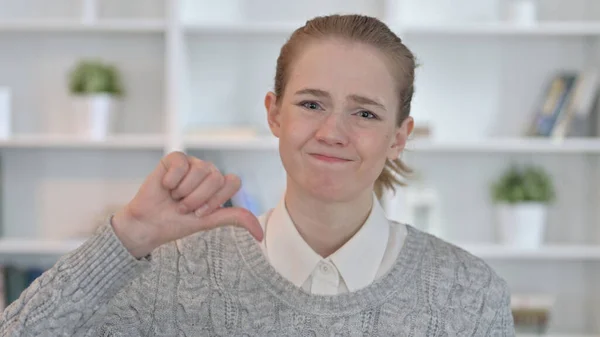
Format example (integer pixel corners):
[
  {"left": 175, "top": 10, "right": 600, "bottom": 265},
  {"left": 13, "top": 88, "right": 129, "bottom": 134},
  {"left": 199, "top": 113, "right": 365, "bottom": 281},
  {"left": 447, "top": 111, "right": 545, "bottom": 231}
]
[{"left": 0, "top": 220, "right": 152, "bottom": 337}]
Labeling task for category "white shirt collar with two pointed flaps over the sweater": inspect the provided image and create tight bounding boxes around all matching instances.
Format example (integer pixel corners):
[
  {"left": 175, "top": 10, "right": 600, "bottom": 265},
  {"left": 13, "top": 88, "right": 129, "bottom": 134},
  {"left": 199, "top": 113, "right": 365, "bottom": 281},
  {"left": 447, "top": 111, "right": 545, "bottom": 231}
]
[{"left": 265, "top": 194, "right": 390, "bottom": 291}]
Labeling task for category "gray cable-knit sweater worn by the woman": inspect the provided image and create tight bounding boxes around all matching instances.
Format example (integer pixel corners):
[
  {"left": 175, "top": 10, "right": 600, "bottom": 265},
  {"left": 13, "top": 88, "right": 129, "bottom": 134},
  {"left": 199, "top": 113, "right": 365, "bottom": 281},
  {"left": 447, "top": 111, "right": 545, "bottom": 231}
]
[{"left": 0, "top": 218, "right": 514, "bottom": 337}]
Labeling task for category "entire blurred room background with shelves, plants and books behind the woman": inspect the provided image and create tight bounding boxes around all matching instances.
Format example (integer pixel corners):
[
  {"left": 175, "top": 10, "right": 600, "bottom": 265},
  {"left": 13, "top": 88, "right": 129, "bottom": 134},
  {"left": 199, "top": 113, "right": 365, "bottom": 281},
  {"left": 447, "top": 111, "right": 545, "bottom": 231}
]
[{"left": 0, "top": 0, "right": 600, "bottom": 337}]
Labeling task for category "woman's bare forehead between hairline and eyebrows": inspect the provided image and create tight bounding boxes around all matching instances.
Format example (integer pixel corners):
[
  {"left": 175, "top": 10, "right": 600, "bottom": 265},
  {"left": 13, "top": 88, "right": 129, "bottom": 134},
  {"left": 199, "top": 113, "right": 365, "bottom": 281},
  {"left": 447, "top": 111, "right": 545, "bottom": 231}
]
[{"left": 287, "top": 39, "right": 396, "bottom": 104}]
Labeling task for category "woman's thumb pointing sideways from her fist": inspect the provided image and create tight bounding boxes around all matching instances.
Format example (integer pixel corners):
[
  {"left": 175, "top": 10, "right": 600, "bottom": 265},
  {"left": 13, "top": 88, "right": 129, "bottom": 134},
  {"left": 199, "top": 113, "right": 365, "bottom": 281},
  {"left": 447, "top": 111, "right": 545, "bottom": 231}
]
[{"left": 199, "top": 207, "right": 264, "bottom": 241}]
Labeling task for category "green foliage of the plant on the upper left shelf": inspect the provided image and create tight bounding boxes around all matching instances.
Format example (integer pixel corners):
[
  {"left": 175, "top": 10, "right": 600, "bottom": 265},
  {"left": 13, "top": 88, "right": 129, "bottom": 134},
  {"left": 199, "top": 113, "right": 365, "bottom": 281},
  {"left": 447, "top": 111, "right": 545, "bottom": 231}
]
[{"left": 69, "top": 60, "right": 124, "bottom": 96}]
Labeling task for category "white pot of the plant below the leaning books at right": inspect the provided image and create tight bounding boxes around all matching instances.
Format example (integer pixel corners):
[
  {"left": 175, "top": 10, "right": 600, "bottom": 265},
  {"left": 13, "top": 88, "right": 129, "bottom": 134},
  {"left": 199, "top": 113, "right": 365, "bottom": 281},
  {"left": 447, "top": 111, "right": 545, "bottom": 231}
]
[{"left": 496, "top": 202, "right": 548, "bottom": 248}]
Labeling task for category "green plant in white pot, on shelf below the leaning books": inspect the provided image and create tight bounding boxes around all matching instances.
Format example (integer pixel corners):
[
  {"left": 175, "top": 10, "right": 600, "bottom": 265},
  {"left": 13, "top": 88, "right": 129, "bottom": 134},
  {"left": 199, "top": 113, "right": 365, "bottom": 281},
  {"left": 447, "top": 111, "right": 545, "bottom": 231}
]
[{"left": 492, "top": 165, "right": 556, "bottom": 248}]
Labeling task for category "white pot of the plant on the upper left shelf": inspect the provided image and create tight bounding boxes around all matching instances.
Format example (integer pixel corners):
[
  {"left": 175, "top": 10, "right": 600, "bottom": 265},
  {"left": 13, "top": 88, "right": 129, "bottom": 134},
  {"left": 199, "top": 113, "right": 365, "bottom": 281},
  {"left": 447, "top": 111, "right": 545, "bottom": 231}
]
[{"left": 73, "top": 94, "right": 117, "bottom": 140}]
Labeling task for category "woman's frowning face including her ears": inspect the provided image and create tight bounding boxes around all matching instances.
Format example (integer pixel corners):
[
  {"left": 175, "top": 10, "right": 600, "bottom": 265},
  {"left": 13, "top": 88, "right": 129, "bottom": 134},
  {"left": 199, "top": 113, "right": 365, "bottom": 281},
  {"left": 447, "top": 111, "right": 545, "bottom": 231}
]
[{"left": 265, "top": 40, "right": 413, "bottom": 201}]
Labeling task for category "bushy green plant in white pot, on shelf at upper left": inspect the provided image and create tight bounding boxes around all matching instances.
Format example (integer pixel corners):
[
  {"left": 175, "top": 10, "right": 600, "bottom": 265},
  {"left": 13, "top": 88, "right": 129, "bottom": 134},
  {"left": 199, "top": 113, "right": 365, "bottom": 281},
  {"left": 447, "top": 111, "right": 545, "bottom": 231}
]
[{"left": 69, "top": 60, "right": 123, "bottom": 140}]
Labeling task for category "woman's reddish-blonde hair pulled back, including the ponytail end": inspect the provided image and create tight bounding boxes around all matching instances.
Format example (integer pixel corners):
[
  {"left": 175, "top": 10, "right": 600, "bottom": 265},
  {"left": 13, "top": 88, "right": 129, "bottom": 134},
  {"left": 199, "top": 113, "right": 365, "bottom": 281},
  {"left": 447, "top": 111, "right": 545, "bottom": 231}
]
[{"left": 274, "top": 15, "right": 416, "bottom": 199}]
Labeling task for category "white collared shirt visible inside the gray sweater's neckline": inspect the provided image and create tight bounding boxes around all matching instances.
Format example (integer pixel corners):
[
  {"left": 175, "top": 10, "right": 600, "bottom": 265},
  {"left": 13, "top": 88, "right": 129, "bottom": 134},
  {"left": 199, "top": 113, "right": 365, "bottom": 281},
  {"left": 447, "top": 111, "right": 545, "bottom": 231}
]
[{"left": 259, "top": 194, "right": 406, "bottom": 295}]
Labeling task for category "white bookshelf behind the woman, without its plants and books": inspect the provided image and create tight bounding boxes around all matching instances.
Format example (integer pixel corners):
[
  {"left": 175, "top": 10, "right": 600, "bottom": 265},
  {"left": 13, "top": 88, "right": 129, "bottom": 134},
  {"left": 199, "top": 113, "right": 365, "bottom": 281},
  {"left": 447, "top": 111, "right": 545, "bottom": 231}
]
[{"left": 0, "top": 0, "right": 600, "bottom": 337}]
